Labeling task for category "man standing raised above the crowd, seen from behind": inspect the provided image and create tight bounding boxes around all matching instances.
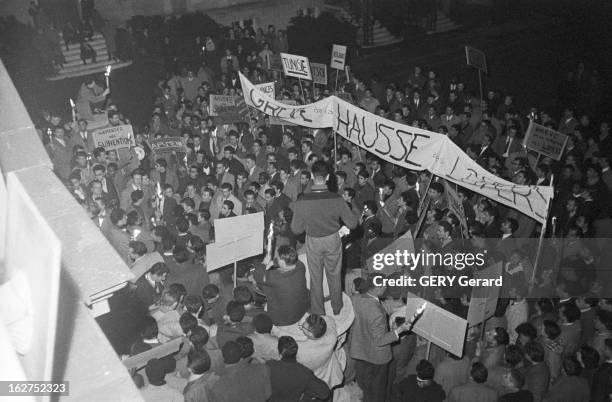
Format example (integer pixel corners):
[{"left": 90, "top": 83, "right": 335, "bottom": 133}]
[{"left": 291, "top": 161, "right": 357, "bottom": 315}]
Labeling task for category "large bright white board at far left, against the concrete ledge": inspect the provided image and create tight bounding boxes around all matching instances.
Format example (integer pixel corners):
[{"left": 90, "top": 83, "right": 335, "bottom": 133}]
[{"left": 0, "top": 173, "right": 62, "bottom": 381}]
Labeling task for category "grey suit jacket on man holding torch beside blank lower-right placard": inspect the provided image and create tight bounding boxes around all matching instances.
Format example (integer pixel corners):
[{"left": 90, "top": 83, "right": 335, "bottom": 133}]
[{"left": 348, "top": 294, "right": 398, "bottom": 364}]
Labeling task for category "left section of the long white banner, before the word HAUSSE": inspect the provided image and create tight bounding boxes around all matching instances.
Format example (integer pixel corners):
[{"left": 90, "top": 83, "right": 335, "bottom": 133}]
[{"left": 240, "top": 74, "right": 334, "bottom": 128}]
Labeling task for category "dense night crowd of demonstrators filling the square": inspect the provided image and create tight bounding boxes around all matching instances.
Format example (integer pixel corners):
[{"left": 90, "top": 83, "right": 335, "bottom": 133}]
[{"left": 28, "top": 3, "right": 612, "bottom": 402}]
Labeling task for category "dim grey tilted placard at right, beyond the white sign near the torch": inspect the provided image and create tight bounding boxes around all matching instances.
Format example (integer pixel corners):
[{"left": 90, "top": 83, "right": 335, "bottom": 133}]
[{"left": 467, "top": 262, "right": 502, "bottom": 327}]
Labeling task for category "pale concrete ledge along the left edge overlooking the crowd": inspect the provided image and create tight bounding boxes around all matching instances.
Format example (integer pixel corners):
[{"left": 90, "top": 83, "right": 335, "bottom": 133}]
[{"left": 0, "top": 62, "right": 142, "bottom": 401}]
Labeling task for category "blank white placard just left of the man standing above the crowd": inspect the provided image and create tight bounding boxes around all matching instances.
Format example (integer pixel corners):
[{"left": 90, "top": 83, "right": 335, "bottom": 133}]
[{"left": 206, "top": 212, "right": 264, "bottom": 272}]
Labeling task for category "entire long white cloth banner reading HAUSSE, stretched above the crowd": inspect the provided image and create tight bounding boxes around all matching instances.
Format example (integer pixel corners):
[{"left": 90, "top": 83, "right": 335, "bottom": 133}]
[{"left": 240, "top": 74, "right": 553, "bottom": 223}]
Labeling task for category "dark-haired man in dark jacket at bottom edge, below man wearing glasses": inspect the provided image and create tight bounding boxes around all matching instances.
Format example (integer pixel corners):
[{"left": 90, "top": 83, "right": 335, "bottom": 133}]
[{"left": 266, "top": 336, "right": 331, "bottom": 402}]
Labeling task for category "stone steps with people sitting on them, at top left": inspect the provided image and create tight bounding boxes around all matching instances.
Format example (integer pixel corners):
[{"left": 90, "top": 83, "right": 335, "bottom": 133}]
[{"left": 46, "top": 33, "right": 132, "bottom": 81}]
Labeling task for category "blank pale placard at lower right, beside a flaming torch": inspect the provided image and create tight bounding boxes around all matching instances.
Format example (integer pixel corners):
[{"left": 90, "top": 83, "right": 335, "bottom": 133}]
[{"left": 406, "top": 292, "right": 467, "bottom": 356}]
